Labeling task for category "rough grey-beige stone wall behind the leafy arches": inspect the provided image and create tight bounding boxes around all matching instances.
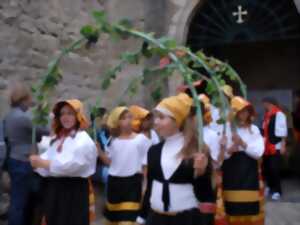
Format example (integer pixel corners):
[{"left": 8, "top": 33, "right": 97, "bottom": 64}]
[{"left": 0, "top": 0, "right": 199, "bottom": 116}]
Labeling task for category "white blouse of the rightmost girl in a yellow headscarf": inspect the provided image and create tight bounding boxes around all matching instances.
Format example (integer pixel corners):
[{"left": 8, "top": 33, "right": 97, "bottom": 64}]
[{"left": 225, "top": 124, "right": 265, "bottom": 159}]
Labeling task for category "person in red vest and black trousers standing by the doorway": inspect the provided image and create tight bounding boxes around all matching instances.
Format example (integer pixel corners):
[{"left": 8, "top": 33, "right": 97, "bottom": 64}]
[{"left": 262, "top": 97, "right": 288, "bottom": 201}]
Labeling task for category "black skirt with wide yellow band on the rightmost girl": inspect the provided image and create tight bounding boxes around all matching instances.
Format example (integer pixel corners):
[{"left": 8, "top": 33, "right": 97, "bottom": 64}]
[{"left": 222, "top": 152, "right": 260, "bottom": 216}]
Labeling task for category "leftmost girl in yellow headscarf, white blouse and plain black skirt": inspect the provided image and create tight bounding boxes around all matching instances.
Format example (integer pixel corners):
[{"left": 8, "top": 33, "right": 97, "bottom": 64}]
[{"left": 30, "top": 99, "right": 97, "bottom": 225}]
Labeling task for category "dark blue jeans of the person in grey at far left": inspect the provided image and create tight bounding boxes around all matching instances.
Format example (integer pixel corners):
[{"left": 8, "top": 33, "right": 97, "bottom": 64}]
[{"left": 8, "top": 159, "right": 38, "bottom": 225}]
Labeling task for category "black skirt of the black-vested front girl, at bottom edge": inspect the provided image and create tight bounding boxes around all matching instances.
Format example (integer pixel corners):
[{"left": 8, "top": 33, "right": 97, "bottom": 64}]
[{"left": 146, "top": 209, "right": 204, "bottom": 225}]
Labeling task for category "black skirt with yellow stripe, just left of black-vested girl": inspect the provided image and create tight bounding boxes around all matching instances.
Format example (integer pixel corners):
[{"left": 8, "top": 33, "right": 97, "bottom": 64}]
[{"left": 104, "top": 174, "right": 142, "bottom": 222}]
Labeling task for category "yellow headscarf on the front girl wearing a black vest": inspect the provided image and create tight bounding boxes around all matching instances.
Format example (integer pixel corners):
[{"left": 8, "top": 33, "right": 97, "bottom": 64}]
[{"left": 156, "top": 93, "right": 193, "bottom": 127}]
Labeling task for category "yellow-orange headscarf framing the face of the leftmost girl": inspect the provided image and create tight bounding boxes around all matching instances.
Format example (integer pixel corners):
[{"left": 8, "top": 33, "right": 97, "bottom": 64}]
[{"left": 53, "top": 99, "right": 89, "bottom": 129}]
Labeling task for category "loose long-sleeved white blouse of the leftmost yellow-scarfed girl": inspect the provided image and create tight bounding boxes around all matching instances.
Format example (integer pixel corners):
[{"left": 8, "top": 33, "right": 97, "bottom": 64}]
[{"left": 36, "top": 131, "right": 97, "bottom": 178}]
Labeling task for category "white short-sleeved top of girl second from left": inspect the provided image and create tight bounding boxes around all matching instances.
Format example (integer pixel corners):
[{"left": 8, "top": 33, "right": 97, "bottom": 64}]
[{"left": 106, "top": 134, "right": 151, "bottom": 177}]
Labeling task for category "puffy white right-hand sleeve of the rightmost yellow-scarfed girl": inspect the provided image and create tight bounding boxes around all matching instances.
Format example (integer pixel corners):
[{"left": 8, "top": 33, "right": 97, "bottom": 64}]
[{"left": 245, "top": 126, "right": 265, "bottom": 159}]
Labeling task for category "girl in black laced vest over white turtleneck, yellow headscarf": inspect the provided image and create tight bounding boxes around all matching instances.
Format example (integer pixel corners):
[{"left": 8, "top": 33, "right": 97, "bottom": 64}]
[{"left": 137, "top": 94, "right": 207, "bottom": 225}]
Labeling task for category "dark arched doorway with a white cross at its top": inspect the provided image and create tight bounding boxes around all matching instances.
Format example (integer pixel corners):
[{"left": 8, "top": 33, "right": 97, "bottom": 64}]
[{"left": 187, "top": 0, "right": 300, "bottom": 176}]
